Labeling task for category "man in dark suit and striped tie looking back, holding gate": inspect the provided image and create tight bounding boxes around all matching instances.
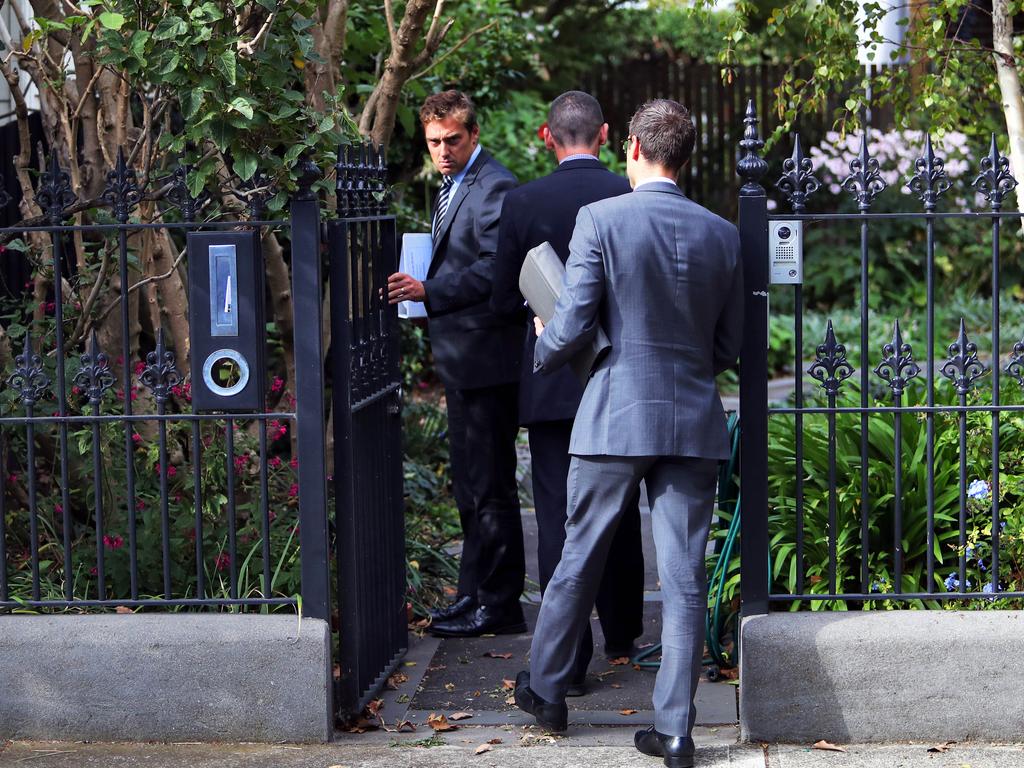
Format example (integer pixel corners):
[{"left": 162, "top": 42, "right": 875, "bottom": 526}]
[{"left": 388, "top": 91, "right": 526, "bottom": 637}]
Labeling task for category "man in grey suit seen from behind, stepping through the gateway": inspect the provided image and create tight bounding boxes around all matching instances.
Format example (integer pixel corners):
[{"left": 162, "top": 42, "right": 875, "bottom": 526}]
[{"left": 515, "top": 99, "right": 742, "bottom": 768}]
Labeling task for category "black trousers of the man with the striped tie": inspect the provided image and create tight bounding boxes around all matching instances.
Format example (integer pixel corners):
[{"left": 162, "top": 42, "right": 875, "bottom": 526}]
[{"left": 445, "top": 384, "right": 526, "bottom": 606}]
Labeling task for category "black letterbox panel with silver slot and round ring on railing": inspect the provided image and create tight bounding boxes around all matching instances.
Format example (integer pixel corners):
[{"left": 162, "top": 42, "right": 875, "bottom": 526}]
[{"left": 187, "top": 230, "right": 266, "bottom": 413}]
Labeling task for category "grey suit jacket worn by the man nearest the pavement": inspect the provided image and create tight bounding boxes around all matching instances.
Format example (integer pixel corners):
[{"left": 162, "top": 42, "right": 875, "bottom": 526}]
[{"left": 535, "top": 182, "right": 743, "bottom": 459}]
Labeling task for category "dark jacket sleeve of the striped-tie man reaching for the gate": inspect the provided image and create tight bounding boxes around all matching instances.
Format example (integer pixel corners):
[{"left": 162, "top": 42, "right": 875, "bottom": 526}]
[{"left": 423, "top": 176, "right": 515, "bottom": 317}]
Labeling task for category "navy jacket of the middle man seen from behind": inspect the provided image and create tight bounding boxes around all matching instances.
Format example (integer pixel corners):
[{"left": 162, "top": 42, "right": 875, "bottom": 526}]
[{"left": 490, "top": 154, "right": 630, "bottom": 425}]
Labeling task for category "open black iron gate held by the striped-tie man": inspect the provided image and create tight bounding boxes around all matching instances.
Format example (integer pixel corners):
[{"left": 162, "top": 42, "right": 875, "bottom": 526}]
[{"left": 327, "top": 147, "right": 408, "bottom": 713}]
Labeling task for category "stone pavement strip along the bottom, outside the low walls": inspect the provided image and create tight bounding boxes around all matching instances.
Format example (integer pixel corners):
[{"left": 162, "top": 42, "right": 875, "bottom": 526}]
[{"left": 6, "top": 737, "right": 1024, "bottom": 768}]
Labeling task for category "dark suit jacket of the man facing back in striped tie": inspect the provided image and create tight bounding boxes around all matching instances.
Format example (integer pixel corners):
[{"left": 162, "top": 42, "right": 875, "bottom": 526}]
[{"left": 423, "top": 150, "right": 523, "bottom": 389}]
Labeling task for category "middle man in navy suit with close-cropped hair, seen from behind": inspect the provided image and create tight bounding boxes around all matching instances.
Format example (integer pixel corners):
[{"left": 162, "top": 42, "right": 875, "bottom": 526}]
[{"left": 490, "top": 91, "right": 644, "bottom": 695}]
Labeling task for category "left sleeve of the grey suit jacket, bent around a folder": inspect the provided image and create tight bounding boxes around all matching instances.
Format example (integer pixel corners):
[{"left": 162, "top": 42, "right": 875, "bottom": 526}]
[{"left": 534, "top": 208, "right": 605, "bottom": 373}]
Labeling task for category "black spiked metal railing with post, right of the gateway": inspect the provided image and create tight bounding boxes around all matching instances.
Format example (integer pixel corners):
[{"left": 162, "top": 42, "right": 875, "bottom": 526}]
[{"left": 737, "top": 101, "right": 1024, "bottom": 615}]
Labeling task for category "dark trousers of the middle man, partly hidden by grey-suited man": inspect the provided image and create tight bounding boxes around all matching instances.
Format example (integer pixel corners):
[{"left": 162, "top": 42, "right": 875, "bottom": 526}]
[{"left": 529, "top": 420, "right": 644, "bottom": 677}]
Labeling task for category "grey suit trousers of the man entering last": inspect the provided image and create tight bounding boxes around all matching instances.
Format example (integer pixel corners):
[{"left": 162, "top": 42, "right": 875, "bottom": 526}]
[{"left": 529, "top": 456, "right": 718, "bottom": 736}]
